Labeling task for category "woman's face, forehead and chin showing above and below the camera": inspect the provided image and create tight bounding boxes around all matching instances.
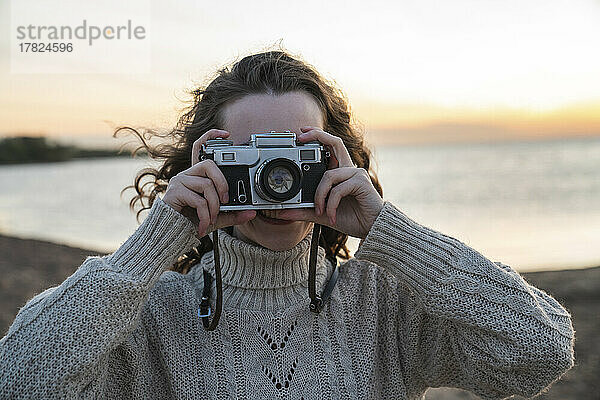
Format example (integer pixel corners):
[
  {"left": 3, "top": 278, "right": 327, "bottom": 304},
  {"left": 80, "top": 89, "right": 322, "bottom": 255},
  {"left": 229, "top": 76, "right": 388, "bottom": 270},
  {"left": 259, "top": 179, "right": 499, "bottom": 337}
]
[{"left": 223, "top": 92, "right": 323, "bottom": 250}]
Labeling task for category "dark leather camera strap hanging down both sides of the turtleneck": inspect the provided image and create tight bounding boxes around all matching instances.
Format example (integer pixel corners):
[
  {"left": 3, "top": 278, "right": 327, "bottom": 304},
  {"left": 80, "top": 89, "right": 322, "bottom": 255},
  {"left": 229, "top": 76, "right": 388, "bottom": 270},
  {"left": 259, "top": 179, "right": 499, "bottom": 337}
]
[{"left": 198, "top": 224, "right": 339, "bottom": 331}]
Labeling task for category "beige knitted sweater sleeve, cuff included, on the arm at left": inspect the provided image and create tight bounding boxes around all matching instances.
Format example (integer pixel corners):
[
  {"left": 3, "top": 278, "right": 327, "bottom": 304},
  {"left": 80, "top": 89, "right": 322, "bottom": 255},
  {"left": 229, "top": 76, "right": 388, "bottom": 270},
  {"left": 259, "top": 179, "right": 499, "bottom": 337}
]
[{"left": 0, "top": 198, "right": 198, "bottom": 399}]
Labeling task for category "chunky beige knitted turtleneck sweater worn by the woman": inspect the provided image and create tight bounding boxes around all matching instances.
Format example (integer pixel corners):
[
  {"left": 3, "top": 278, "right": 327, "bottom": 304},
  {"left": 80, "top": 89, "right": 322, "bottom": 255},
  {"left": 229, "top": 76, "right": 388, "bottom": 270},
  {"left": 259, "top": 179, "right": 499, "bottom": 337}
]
[{"left": 0, "top": 198, "right": 574, "bottom": 400}]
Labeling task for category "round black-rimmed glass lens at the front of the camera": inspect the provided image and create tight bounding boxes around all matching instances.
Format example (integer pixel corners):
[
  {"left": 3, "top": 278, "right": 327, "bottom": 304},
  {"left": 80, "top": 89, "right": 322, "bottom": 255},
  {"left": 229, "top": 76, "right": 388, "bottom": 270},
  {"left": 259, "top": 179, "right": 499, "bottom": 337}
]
[{"left": 256, "top": 158, "right": 302, "bottom": 202}]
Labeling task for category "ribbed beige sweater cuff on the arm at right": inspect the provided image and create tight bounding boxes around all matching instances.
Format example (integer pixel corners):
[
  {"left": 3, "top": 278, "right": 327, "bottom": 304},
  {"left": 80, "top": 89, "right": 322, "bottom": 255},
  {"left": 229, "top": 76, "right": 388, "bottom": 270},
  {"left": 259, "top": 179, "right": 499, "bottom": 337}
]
[{"left": 355, "top": 201, "right": 465, "bottom": 294}]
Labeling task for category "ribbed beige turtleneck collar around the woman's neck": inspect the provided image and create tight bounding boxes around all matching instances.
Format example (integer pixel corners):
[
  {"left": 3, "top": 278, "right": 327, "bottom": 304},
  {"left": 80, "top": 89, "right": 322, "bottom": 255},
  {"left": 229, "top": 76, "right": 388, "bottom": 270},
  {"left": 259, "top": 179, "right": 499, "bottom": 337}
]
[{"left": 190, "top": 230, "right": 332, "bottom": 310}]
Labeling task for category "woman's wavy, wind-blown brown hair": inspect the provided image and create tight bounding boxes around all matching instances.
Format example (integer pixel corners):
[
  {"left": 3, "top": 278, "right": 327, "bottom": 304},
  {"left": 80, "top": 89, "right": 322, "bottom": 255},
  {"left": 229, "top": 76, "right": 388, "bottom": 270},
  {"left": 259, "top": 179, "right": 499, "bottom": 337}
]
[{"left": 113, "top": 46, "right": 383, "bottom": 273}]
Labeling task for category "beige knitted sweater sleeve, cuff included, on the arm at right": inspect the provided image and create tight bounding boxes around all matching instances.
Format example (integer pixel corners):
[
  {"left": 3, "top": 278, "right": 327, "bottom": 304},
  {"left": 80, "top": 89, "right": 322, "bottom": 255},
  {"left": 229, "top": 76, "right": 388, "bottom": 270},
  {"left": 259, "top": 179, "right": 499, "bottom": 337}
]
[{"left": 355, "top": 202, "right": 574, "bottom": 399}]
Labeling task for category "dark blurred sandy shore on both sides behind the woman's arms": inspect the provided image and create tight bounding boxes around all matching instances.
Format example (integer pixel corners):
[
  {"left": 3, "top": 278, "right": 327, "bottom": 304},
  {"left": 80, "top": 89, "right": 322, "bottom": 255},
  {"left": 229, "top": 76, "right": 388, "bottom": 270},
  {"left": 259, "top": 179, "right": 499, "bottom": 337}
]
[{"left": 0, "top": 235, "right": 600, "bottom": 399}]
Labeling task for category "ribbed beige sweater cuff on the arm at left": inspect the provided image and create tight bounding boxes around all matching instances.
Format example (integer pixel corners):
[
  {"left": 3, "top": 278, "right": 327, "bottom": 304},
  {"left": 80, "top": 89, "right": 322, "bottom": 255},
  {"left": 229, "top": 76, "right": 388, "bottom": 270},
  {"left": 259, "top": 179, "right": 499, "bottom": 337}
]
[{"left": 106, "top": 196, "right": 200, "bottom": 283}]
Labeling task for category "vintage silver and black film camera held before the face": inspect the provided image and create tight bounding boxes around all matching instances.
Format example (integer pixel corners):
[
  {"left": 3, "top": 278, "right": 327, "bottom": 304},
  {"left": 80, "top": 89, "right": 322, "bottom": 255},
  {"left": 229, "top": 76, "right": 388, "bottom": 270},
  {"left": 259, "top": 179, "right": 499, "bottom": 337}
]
[{"left": 199, "top": 131, "right": 330, "bottom": 211}]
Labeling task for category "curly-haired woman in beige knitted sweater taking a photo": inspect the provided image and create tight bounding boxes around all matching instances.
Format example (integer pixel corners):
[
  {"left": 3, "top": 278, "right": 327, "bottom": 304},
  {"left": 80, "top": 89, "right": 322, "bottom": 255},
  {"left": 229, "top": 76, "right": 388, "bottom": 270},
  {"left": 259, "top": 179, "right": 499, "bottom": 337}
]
[{"left": 0, "top": 51, "right": 574, "bottom": 399}]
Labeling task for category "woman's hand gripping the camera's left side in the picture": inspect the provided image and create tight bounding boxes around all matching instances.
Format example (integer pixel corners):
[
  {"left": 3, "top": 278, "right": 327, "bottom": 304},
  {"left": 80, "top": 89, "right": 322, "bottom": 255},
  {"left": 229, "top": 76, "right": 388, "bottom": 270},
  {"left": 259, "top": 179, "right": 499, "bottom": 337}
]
[{"left": 162, "top": 129, "right": 256, "bottom": 237}]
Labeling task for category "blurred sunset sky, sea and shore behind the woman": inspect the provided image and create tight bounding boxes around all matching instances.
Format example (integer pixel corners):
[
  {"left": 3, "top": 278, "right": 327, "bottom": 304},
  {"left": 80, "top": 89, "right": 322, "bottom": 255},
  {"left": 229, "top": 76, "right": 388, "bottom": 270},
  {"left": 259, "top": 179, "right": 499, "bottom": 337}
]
[{"left": 0, "top": 0, "right": 600, "bottom": 399}]
